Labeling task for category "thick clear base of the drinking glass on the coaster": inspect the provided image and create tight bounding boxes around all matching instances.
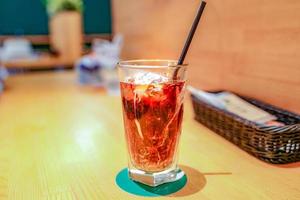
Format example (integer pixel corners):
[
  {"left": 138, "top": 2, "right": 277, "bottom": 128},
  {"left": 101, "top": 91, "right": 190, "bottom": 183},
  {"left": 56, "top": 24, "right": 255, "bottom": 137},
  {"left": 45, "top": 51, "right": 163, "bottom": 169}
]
[{"left": 128, "top": 168, "right": 184, "bottom": 187}]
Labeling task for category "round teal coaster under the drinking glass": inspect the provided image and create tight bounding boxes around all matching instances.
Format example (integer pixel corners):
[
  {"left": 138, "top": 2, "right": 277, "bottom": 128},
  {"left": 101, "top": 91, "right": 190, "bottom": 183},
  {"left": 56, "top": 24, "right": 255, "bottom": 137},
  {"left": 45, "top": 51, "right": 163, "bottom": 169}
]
[{"left": 116, "top": 168, "right": 187, "bottom": 197}]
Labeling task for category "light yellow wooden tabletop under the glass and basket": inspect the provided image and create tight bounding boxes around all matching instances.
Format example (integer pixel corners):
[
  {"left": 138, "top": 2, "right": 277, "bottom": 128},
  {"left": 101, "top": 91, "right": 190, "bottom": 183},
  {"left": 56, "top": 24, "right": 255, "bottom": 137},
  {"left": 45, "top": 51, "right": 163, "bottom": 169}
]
[{"left": 0, "top": 72, "right": 300, "bottom": 200}]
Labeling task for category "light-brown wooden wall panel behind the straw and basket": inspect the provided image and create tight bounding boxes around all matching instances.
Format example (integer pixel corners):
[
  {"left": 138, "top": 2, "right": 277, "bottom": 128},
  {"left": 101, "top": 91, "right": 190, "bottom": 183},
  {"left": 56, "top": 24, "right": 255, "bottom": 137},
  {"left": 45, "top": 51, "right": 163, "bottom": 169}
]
[{"left": 112, "top": 0, "right": 300, "bottom": 113}]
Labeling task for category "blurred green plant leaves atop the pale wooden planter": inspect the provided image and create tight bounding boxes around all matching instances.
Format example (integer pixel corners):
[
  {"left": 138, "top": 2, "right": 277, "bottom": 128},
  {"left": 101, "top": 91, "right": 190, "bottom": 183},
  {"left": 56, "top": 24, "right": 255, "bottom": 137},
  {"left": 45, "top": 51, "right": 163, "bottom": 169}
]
[{"left": 44, "top": 0, "right": 83, "bottom": 16}]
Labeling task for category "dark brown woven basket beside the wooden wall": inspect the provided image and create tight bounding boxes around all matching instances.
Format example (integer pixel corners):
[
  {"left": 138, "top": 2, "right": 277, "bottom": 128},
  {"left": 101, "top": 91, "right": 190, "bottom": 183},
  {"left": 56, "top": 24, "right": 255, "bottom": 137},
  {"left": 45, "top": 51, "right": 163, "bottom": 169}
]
[{"left": 191, "top": 91, "right": 300, "bottom": 164}]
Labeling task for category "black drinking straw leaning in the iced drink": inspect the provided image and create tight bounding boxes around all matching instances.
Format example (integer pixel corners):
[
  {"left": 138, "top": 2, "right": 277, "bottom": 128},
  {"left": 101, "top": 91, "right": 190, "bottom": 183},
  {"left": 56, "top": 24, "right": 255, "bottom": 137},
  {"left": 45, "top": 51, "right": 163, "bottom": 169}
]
[{"left": 173, "top": 1, "right": 206, "bottom": 79}]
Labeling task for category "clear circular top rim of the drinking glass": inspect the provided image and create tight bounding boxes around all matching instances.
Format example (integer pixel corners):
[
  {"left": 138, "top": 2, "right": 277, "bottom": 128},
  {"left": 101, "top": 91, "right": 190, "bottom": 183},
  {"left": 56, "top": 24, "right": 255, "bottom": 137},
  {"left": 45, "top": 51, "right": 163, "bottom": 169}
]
[{"left": 117, "top": 59, "right": 187, "bottom": 69}]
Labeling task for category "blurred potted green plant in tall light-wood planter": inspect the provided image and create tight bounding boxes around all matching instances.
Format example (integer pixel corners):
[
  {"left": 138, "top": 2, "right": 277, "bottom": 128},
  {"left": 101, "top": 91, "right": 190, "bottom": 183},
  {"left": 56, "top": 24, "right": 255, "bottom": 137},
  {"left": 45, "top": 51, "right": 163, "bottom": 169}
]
[{"left": 45, "top": 0, "right": 83, "bottom": 64}]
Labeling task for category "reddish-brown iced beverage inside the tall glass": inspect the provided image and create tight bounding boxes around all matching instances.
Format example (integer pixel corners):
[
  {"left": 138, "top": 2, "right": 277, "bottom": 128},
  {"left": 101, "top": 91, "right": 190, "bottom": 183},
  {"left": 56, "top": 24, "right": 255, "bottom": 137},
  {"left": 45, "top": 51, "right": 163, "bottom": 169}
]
[{"left": 120, "top": 81, "right": 185, "bottom": 172}]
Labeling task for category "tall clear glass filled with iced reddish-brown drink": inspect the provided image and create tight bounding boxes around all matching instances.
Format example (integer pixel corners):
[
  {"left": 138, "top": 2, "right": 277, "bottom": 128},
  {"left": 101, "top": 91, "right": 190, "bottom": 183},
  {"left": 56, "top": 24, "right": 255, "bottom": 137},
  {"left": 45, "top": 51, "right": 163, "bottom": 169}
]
[{"left": 118, "top": 60, "right": 186, "bottom": 186}]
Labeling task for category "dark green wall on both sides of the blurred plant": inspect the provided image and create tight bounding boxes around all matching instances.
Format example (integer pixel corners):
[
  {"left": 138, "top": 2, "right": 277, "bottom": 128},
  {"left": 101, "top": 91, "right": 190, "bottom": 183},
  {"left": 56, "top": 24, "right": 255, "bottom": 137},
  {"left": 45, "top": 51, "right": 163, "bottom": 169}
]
[{"left": 0, "top": 0, "right": 111, "bottom": 35}]
